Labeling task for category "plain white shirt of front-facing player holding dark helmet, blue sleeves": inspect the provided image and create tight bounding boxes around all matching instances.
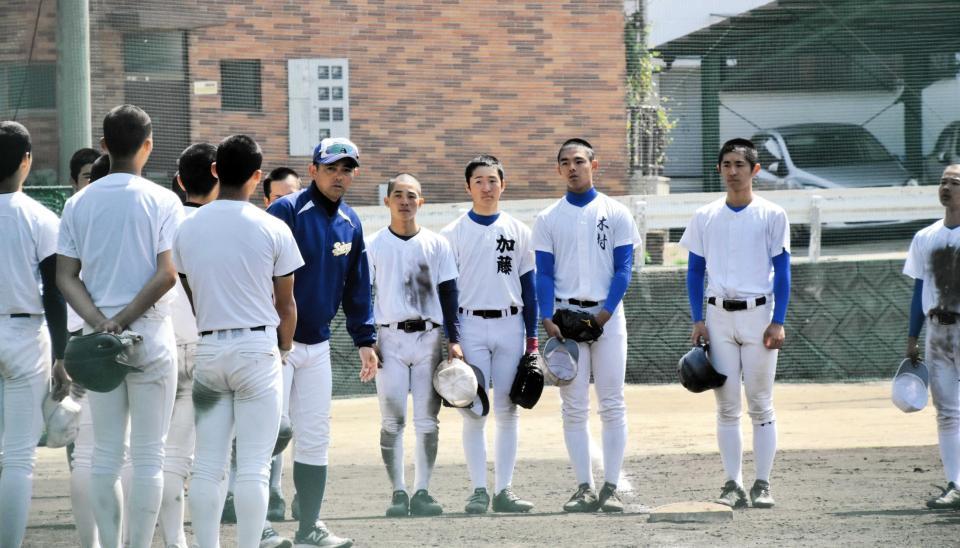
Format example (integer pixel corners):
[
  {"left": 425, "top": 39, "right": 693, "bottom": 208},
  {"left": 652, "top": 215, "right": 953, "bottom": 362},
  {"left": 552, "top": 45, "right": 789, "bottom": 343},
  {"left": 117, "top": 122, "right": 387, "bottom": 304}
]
[{"left": 680, "top": 194, "right": 790, "bottom": 299}]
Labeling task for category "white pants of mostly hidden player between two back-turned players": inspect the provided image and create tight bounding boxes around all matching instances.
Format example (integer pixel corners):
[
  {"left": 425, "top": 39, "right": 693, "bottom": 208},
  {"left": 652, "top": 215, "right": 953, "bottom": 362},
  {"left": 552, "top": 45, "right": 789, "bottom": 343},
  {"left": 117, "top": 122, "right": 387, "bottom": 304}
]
[{"left": 159, "top": 343, "right": 197, "bottom": 546}]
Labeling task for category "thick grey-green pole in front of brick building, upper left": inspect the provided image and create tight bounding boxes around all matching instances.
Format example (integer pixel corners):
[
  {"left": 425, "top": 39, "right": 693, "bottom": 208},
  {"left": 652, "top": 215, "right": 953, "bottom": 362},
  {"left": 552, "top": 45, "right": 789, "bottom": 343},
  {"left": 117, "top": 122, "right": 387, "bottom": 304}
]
[{"left": 57, "top": 0, "right": 93, "bottom": 184}]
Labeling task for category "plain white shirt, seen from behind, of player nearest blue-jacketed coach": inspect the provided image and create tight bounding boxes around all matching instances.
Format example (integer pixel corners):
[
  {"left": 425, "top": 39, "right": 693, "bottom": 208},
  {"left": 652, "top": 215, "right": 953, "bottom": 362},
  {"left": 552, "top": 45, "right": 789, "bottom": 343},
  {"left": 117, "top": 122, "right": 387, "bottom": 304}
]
[{"left": 173, "top": 200, "right": 304, "bottom": 331}]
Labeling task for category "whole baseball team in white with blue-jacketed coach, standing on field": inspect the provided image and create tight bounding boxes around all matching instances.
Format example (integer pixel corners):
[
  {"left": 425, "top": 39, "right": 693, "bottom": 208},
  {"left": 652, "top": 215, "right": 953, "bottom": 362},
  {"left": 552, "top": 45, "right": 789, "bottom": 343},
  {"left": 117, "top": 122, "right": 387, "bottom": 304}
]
[{"left": 0, "top": 105, "right": 960, "bottom": 548}]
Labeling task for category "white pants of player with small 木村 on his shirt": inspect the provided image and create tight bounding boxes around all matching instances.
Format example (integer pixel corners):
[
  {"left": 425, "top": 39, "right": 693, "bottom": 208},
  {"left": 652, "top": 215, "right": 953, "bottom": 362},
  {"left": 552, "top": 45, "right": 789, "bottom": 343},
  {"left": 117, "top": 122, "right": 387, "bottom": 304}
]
[{"left": 560, "top": 305, "right": 627, "bottom": 488}]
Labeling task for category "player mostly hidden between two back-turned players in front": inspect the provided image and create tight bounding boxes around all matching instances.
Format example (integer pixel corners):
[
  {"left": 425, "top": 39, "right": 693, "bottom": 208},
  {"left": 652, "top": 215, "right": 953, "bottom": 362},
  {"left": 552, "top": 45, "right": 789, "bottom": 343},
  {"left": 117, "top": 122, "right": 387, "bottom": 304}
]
[{"left": 159, "top": 143, "right": 218, "bottom": 548}]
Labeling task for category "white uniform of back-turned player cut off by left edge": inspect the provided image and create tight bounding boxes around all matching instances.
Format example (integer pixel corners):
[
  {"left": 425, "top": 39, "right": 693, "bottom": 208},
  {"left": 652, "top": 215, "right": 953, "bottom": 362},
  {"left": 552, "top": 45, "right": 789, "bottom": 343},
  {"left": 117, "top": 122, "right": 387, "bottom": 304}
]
[{"left": 0, "top": 191, "right": 59, "bottom": 546}]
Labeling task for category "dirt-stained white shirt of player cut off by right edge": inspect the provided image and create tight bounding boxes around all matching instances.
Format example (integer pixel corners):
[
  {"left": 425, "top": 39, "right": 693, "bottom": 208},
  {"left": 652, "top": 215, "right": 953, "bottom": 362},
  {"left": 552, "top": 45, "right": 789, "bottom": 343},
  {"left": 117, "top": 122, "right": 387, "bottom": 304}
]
[{"left": 903, "top": 219, "right": 960, "bottom": 314}]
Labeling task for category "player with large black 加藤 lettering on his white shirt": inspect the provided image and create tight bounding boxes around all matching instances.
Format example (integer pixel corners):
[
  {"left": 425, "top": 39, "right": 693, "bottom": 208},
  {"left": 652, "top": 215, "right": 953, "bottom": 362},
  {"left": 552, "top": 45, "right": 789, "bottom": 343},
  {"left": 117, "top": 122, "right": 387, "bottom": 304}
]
[{"left": 440, "top": 154, "right": 537, "bottom": 514}]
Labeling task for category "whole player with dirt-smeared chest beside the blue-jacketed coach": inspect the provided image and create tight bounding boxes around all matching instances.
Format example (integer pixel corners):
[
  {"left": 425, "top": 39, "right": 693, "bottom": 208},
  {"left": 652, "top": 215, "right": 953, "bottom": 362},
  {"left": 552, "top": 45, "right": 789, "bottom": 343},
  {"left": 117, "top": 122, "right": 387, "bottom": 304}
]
[{"left": 363, "top": 173, "right": 463, "bottom": 517}]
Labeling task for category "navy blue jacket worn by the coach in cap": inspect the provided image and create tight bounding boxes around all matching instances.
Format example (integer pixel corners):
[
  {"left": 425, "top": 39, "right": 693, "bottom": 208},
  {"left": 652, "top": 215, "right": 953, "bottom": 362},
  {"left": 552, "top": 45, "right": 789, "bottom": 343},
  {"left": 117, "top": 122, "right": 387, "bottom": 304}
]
[{"left": 267, "top": 183, "right": 376, "bottom": 346}]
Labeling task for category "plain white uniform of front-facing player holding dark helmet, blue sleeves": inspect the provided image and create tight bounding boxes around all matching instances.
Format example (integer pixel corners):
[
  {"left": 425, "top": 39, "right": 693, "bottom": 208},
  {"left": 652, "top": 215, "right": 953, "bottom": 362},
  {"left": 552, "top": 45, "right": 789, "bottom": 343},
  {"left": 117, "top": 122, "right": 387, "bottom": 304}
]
[{"left": 680, "top": 194, "right": 790, "bottom": 485}]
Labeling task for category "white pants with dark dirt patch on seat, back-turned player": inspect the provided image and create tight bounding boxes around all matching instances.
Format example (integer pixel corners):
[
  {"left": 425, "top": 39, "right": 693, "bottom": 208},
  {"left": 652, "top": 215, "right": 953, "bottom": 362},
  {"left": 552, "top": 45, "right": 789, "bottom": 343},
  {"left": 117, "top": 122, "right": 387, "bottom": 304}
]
[{"left": 190, "top": 327, "right": 283, "bottom": 548}]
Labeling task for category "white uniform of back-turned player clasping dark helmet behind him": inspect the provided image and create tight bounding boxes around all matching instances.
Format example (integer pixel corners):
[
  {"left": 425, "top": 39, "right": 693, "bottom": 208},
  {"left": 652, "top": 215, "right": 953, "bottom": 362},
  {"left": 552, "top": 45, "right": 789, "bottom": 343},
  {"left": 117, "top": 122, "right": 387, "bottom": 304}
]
[{"left": 57, "top": 173, "right": 183, "bottom": 547}]
